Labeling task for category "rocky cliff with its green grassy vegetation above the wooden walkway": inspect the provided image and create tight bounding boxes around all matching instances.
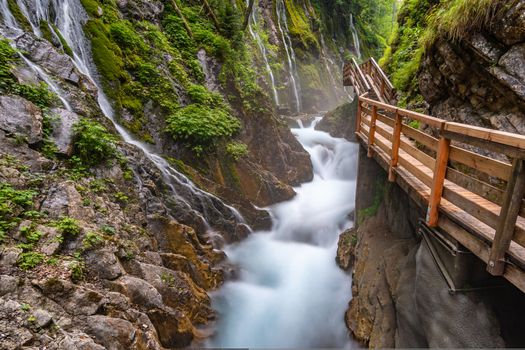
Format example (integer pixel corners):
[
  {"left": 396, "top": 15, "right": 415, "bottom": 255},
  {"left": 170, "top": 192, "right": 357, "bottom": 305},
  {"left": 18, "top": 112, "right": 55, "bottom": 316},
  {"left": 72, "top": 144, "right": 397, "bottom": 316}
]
[{"left": 382, "top": 0, "right": 525, "bottom": 137}]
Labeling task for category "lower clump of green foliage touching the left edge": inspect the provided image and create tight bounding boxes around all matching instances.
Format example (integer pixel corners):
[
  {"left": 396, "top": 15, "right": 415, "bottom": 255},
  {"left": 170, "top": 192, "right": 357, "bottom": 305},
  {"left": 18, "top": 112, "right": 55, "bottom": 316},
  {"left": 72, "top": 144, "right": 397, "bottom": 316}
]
[{"left": 0, "top": 182, "right": 37, "bottom": 243}]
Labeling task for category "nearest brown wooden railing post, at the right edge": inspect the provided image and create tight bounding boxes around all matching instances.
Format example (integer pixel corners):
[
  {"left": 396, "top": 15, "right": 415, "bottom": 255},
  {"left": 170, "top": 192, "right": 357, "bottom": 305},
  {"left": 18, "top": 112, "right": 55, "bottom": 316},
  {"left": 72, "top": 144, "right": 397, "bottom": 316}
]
[{"left": 487, "top": 158, "right": 525, "bottom": 276}]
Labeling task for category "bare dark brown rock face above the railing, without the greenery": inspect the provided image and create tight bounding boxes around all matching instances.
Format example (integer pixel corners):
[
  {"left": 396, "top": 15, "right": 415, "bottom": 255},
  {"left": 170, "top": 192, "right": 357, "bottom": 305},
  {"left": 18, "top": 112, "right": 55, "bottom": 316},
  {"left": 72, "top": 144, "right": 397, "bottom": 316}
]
[{"left": 419, "top": 1, "right": 525, "bottom": 134}]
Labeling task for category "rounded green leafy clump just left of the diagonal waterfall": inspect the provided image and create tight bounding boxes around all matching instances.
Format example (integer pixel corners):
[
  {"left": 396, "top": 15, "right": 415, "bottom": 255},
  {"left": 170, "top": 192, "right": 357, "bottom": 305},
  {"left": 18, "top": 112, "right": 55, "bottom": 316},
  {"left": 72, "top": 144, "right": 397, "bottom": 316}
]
[{"left": 73, "top": 118, "right": 116, "bottom": 166}]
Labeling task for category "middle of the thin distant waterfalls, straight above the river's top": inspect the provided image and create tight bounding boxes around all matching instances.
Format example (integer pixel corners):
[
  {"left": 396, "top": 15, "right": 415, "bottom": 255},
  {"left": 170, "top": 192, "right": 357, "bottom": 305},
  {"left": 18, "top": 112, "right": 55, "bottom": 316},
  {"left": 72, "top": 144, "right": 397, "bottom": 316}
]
[{"left": 276, "top": 0, "right": 302, "bottom": 113}]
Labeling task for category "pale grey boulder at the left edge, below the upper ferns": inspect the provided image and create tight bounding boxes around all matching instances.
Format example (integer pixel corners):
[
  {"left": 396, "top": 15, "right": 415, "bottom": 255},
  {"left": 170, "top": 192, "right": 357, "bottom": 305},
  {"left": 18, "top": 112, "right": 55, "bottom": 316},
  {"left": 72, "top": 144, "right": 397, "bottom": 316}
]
[{"left": 0, "top": 96, "right": 42, "bottom": 144}]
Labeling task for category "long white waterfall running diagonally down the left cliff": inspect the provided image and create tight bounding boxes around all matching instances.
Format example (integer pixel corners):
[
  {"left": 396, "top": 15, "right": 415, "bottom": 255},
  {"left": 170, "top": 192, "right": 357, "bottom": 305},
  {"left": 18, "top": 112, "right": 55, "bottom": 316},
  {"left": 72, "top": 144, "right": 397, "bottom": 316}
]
[{"left": 1, "top": 0, "right": 244, "bottom": 235}]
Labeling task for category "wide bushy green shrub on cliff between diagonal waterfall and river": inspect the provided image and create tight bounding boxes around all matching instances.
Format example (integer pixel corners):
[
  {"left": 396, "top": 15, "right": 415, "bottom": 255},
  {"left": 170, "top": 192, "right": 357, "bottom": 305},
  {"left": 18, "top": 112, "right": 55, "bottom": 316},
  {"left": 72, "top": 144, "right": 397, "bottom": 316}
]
[{"left": 166, "top": 104, "right": 241, "bottom": 148}]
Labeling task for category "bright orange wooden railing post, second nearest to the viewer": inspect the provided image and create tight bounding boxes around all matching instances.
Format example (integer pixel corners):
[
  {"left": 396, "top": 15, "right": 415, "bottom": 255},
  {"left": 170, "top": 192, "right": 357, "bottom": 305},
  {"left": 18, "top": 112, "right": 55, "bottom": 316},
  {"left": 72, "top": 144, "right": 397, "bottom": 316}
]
[{"left": 426, "top": 130, "right": 450, "bottom": 227}]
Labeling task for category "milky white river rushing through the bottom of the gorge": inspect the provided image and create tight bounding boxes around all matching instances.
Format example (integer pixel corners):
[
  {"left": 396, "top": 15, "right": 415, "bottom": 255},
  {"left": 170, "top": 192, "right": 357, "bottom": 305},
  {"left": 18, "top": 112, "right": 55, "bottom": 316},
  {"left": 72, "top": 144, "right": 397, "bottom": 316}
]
[{"left": 209, "top": 117, "right": 357, "bottom": 348}]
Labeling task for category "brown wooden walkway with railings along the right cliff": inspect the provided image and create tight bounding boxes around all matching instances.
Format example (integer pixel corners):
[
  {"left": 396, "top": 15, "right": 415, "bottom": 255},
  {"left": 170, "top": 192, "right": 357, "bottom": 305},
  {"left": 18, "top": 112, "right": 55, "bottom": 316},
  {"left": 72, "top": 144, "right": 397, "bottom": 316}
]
[{"left": 344, "top": 59, "right": 525, "bottom": 292}]
